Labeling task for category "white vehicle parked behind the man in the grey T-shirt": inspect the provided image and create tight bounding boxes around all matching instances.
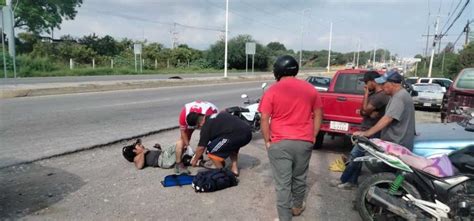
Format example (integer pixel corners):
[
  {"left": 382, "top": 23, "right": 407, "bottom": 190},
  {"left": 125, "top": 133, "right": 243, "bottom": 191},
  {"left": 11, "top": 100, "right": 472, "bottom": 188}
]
[{"left": 412, "top": 83, "right": 446, "bottom": 109}]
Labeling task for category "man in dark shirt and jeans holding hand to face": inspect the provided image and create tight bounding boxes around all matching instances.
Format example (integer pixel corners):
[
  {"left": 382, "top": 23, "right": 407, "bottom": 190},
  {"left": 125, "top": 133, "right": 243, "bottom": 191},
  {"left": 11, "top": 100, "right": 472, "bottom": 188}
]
[{"left": 331, "top": 71, "right": 390, "bottom": 189}]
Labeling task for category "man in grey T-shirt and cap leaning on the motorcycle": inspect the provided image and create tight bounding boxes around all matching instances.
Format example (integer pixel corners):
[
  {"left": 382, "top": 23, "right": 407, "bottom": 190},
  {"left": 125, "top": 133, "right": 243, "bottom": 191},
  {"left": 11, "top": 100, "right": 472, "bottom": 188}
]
[{"left": 354, "top": 70, "right": 415, "bottom": 151}]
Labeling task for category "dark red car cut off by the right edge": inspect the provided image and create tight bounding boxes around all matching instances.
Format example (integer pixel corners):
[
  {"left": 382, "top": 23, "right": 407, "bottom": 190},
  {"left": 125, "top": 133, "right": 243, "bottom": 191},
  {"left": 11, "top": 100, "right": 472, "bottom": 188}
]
[{"left": 441, "top": 68, "right": 474, "bottom": 122}]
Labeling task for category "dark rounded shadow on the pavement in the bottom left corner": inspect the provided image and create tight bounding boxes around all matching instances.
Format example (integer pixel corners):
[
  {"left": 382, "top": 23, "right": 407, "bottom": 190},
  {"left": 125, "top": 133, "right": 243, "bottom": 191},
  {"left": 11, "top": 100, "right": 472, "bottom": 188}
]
[{"left": 0, "top": 159, "right": 85, "bottom": 219}]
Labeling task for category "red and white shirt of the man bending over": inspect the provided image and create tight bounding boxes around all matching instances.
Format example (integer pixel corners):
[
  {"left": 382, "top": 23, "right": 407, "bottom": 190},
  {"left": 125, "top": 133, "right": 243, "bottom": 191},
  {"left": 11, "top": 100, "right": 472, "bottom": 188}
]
[{"left": 179, "top": 101, "right": 218, "bottom": 130}]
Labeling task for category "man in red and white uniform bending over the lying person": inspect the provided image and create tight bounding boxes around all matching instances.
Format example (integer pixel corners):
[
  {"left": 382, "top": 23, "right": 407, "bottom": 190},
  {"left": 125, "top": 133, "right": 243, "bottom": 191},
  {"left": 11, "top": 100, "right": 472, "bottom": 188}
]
[{"left": 175, "top": 101, "right": 218, "bottom": 174}]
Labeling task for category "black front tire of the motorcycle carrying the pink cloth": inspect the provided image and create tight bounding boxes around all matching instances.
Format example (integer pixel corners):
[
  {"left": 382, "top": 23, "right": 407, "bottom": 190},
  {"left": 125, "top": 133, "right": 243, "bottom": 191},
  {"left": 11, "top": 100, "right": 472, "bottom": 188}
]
[{"left": 355, "top": 173, "right": 421, "bottom": 221}]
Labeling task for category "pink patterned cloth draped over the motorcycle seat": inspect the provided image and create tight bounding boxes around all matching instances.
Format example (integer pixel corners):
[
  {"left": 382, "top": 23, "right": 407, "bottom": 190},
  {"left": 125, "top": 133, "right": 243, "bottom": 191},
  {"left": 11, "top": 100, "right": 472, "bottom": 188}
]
[{"left": 370, "top": 138, "right": 454, "bottom": 177}]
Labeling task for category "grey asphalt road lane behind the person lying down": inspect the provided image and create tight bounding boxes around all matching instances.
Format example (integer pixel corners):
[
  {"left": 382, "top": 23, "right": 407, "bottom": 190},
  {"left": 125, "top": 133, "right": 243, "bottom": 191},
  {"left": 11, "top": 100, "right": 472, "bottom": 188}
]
[{"left": 0, "top": 82, "right": 270, "bottom": 167}]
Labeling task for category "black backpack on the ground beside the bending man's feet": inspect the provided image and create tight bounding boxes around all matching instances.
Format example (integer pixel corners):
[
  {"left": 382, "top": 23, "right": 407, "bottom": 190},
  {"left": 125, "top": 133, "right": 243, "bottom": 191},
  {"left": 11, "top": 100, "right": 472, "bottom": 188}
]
[{"left": 191, "top": 168, "right": 238, "bottom": 192}]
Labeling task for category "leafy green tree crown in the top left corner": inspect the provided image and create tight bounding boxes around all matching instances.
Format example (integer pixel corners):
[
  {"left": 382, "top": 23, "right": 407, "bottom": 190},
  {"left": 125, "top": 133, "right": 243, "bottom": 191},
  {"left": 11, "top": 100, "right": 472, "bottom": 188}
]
[{"left": 12, "top": 0, "right": 82, "bottom": 34}]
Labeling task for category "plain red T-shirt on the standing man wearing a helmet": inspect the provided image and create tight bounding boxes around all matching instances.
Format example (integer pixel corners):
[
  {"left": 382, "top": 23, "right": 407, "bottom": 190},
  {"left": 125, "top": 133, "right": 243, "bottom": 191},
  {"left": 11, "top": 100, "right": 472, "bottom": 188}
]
[{"left": 258, "top": 77, "right": 322, "bottom": 143}]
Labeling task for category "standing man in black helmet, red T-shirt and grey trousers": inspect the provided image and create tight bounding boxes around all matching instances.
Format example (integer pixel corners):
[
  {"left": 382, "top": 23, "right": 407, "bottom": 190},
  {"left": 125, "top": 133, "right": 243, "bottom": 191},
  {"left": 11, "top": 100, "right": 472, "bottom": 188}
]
[{"left": 259, "top": 55, "right": 322, "bottom": 221}]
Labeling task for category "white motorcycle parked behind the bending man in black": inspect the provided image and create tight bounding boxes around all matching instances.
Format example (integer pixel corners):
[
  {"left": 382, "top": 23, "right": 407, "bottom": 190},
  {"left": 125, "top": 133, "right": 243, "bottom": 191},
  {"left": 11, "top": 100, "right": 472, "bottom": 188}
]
[{"left": 225, "top": 83, "right": 267, "bottom": 132}]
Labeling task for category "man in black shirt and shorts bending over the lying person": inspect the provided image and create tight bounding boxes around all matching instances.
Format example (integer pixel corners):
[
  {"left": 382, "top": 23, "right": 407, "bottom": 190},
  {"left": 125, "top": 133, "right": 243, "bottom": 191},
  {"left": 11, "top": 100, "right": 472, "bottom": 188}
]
[{"left": 186, "top": 112, "right": 252, "bottom": 176}]
